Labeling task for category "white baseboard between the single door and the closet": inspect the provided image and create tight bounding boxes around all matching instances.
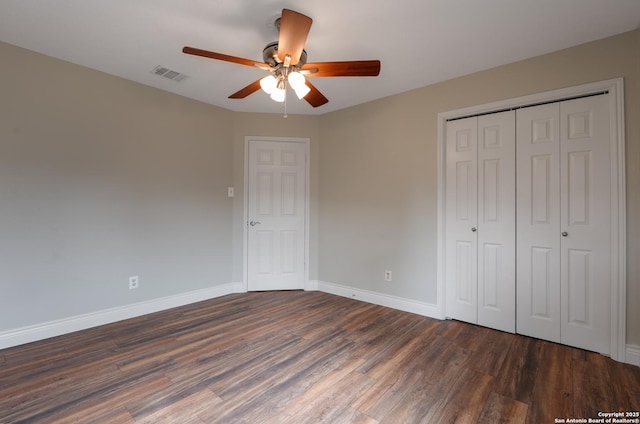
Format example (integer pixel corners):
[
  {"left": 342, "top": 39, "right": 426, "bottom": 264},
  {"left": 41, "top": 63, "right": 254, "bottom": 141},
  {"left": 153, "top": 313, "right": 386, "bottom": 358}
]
[{"left": 318, "top": 281, "right": 444, "bottom": 319}]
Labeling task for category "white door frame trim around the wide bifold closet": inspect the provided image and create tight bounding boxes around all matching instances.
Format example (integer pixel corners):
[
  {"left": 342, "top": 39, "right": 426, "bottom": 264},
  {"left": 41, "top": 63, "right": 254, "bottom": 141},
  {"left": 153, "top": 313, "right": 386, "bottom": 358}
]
[{"left": 436, "top": 78, "right": 627, "bottom": 362}]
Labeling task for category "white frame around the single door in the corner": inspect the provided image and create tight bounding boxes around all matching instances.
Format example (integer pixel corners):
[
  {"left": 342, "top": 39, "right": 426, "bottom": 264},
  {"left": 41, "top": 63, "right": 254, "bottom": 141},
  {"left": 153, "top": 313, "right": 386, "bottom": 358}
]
[{"left": 242, "top": 136, "right": 312, "bottom": 292}]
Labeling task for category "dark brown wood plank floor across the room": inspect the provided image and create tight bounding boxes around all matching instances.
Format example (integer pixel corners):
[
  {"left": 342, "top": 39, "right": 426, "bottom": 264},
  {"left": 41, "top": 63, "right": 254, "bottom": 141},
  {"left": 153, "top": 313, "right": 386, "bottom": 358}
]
[{"left": 0, "top": 292, "right": 640, "bottom": 424}]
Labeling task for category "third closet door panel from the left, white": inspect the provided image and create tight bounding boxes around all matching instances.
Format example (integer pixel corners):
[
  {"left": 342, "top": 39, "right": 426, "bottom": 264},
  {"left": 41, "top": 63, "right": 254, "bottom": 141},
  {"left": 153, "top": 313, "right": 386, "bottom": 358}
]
[{"left": 516, "top": 103, "right": 560, "bottom": 342}]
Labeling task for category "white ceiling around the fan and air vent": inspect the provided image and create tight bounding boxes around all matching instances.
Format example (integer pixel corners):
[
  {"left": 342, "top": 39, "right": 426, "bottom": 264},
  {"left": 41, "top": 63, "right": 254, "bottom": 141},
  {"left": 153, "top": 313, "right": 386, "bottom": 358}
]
[{"left": 0, "top": 0, "right": 640, "bottom": 114}]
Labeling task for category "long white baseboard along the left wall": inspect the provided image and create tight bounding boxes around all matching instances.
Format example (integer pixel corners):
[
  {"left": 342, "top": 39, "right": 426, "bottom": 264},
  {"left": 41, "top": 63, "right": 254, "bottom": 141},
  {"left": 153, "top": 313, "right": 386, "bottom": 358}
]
[{"left": 0, "top": 283, "right": 239, "bottom": 349}]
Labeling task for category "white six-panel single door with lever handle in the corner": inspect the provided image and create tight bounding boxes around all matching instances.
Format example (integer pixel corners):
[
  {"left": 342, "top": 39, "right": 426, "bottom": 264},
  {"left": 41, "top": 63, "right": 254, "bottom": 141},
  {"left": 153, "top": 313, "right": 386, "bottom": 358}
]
[{"left": 247, "top": 140, "right": 307, "bottom": 291}]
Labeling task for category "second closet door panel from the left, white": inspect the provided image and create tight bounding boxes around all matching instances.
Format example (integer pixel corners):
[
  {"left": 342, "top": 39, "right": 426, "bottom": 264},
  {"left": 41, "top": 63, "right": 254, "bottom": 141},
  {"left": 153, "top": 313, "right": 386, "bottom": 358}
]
[{"left": 477, "top": 111, "right": 516, "bottom": 333}]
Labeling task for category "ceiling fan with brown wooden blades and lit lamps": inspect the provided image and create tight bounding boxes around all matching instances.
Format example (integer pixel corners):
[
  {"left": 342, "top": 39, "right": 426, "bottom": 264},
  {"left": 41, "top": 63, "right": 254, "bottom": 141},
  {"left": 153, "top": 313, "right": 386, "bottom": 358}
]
[{"left": 182, "top": 9, "right": 380, "bottom": 107}]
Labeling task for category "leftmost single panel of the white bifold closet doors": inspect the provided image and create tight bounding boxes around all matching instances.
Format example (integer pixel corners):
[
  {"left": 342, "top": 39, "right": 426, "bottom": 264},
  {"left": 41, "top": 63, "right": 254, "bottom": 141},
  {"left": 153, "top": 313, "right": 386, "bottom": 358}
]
[{"left": 445, "top": 117, "right": 478, "bottom": 323}]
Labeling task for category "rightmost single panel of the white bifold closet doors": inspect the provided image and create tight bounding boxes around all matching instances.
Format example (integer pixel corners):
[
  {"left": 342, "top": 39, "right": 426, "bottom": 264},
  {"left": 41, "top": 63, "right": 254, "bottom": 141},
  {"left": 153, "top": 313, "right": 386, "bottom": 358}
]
[{"left": 560, "top": 95, "right": 611, "bottom": 354}]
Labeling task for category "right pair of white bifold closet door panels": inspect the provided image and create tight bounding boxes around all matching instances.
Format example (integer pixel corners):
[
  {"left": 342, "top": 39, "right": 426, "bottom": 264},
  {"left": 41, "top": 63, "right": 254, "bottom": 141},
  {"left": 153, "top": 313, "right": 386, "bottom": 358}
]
[{"left": 517, "top": 95, "right": 611, "bottom": 354}]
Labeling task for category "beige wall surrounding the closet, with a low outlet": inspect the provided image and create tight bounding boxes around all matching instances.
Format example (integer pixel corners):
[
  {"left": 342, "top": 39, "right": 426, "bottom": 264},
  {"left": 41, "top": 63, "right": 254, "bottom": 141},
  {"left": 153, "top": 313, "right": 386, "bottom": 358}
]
[{"left": 319, "top": 30, "right": 640, "bottom": 345}]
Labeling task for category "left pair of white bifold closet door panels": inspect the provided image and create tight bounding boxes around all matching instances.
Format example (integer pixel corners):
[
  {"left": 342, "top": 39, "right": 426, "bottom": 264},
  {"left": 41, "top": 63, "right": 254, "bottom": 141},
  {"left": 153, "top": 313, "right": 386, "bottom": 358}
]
[{"left": 446, "top": 111, "right": 515, "bottom": 332}]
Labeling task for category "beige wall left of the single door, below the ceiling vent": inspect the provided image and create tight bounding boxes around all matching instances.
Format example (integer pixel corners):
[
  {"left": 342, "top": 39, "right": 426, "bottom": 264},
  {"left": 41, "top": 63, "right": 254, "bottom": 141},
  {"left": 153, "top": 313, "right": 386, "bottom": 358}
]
[{"left": 0, "top": 44, "right": 234, "bottom": 332}]
